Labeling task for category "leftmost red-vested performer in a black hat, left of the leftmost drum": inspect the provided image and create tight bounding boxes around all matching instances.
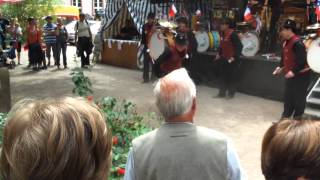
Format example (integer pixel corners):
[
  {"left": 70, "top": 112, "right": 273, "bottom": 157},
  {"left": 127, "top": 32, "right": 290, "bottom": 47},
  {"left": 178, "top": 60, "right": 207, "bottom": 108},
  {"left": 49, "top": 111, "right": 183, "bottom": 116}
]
[{"left": 141, "top": 12, "right": 155, "bottom": 83}]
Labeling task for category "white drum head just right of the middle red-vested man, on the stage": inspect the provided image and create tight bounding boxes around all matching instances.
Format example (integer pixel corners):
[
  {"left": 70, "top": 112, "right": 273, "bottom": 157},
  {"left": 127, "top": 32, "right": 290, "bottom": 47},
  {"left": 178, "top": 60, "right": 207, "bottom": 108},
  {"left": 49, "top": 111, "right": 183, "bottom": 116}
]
[{"left": 241, "top": 32, "right": 259, "bottom": 57}]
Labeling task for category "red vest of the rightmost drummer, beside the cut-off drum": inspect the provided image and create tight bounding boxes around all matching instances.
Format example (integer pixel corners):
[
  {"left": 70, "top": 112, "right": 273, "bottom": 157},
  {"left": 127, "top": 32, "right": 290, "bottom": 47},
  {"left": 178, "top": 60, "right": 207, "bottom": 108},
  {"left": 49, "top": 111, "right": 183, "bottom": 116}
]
[{"left": 282, "top": 35, "right": 309, "bottom": 73}]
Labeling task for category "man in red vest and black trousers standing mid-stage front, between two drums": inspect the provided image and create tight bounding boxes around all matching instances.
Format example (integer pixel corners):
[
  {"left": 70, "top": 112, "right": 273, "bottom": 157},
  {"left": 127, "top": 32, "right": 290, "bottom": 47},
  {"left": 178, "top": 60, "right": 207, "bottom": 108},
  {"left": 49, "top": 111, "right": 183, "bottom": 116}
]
[{"left": 215, "top": 19, "right": 243, "bottom": 99}]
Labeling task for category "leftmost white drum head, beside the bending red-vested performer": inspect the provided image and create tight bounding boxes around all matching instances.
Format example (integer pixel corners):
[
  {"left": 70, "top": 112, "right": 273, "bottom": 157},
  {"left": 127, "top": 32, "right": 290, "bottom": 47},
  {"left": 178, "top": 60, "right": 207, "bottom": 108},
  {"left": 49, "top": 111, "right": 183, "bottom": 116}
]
[{"left": 149, "top": 32, "right": 166, "bottom": 60}]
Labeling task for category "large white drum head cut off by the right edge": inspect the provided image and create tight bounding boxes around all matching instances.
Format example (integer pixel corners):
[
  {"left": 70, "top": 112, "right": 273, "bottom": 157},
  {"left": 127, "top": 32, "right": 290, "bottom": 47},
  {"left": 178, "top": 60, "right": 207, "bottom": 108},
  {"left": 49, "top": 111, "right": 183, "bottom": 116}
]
[{"left": 307, "top": 38, "right": 320, "bottom": 73}]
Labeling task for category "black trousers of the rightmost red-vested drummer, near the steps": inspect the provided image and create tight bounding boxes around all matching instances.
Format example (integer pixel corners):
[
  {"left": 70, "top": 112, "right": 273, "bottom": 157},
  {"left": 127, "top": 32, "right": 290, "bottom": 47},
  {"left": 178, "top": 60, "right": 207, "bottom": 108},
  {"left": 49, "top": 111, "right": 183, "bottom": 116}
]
[{"left": 282, "top": 72, "right": 310, "bottom": 120}]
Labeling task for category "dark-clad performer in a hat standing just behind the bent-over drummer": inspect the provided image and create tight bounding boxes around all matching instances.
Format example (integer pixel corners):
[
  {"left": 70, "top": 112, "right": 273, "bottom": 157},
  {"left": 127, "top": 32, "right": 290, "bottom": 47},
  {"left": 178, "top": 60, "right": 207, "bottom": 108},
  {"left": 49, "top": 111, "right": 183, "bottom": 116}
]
[{"left": 176, "top": 17, "right": 201, "bottom": 84}]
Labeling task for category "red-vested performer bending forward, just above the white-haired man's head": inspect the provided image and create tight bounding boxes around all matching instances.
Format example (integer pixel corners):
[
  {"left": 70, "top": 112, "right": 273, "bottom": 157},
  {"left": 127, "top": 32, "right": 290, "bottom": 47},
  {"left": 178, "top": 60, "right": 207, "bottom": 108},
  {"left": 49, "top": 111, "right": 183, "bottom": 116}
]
[{"left": 154, "top": 33, "right": 188, "bottom": 78}]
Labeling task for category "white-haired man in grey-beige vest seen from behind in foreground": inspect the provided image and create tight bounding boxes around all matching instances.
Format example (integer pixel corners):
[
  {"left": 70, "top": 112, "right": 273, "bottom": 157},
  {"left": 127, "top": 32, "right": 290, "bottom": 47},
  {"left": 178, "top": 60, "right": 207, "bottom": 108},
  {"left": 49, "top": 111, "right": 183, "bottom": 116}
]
[{"left": 124, "top": 68, "right": 246, "bottom": 180}]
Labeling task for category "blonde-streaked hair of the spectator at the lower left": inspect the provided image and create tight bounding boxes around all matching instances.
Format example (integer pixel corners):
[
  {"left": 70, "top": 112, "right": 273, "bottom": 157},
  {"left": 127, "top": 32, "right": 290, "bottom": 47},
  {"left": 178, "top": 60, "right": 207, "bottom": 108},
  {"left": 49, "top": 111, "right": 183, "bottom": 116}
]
[{"left": 0, "top": 97, "right": 112, "bottom": 180}]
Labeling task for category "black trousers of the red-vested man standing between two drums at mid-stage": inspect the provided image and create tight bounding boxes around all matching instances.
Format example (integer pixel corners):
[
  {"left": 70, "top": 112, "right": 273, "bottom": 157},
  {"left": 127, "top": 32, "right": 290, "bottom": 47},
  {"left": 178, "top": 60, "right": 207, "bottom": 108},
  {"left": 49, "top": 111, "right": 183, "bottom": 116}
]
[{"left": 219, "top": 59, "right": 240, "bottom": 96}]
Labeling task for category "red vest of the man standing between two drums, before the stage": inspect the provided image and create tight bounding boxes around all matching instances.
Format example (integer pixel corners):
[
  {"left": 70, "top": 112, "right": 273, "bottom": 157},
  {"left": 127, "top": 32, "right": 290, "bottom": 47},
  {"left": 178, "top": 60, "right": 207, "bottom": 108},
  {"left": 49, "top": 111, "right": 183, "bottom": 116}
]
[{"left": 220, "top": 29, "right": 235, "bottom": 60}]
